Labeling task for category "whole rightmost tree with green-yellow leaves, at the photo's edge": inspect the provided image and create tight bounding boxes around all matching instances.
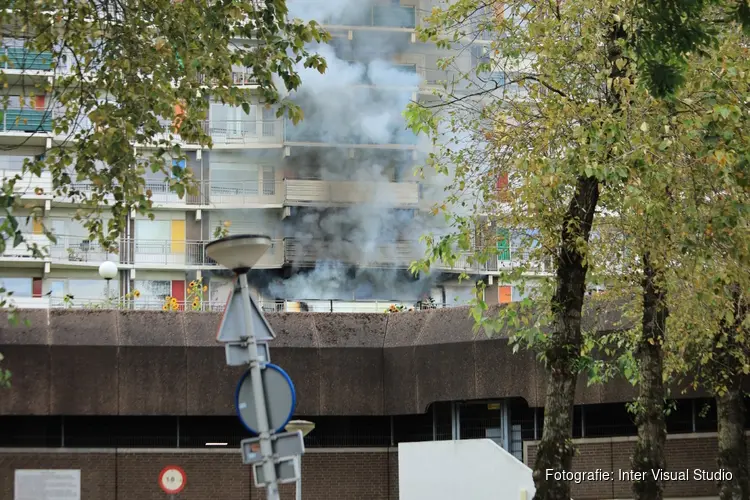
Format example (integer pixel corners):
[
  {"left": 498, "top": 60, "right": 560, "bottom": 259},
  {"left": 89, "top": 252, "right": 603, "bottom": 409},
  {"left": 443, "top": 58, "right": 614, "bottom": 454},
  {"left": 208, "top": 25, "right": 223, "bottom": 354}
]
[{"left": 669, "top": 30, "right": 750, "bottom": 499}]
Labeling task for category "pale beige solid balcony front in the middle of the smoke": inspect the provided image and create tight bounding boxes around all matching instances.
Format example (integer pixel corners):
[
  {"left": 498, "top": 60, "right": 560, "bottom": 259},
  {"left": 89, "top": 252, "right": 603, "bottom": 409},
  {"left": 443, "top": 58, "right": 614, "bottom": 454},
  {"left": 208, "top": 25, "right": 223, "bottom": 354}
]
[{"left": 284, "top": 179, "right": 419, "bottom": 207}]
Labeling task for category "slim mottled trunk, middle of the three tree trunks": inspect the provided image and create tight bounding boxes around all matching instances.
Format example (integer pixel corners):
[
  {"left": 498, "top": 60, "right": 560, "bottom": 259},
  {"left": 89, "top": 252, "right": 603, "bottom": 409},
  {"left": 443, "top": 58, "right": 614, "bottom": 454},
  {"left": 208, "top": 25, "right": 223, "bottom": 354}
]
[{"left": 631, "top": 253, "right": 668, "bottom": 500}]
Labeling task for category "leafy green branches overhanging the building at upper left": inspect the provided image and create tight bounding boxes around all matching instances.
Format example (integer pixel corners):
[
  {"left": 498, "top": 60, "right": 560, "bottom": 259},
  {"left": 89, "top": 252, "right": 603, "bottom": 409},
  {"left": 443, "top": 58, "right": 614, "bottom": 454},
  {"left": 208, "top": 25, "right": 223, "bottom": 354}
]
[{"left": 0, "top": 0, "right": 329, "bottom": 247}]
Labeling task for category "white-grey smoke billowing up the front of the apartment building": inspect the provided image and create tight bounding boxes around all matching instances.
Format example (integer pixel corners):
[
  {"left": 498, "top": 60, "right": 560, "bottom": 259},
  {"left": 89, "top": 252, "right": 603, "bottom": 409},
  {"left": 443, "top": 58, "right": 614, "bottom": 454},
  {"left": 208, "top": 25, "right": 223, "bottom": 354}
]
[{"left": 265, "top": 0, "right": 458, "bottom": 300}]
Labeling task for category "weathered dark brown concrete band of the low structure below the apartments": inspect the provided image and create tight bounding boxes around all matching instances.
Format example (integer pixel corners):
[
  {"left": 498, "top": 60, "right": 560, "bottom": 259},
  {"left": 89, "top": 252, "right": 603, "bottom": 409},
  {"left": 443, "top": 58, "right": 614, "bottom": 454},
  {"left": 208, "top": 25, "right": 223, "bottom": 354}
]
[{"left": 0, "top": 307, "right": 676, "bottom": 416}]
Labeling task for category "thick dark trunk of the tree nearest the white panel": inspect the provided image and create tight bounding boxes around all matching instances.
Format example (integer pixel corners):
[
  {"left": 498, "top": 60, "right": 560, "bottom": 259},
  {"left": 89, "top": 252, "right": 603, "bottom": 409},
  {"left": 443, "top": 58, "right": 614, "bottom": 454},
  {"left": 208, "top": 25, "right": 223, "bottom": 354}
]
[{"left": 534, "top": 177, "right": 599, "bottom": 500}]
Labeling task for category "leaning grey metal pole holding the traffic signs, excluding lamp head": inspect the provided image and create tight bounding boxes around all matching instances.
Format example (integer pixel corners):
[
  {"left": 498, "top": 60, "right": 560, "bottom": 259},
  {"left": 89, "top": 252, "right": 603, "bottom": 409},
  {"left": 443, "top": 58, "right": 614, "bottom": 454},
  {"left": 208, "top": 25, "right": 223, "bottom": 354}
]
[{"left": 239, "top": 273, "right": 279, "bottom": 500}]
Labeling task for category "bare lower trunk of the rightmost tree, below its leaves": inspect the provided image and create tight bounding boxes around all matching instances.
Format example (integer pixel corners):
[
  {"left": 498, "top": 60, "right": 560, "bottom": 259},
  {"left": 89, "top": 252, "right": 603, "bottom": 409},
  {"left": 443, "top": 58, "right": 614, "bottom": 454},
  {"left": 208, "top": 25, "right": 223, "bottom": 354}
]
[{"left": 716, "top": 384, "right": 750, "bottom": 500}]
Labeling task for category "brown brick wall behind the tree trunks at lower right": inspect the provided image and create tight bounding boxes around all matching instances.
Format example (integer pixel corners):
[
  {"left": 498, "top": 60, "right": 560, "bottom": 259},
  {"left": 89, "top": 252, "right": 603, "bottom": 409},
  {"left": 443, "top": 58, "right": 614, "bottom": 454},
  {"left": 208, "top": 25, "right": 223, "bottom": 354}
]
[{"left": 524, "top": 433, "right": 744, "bottom": 500}]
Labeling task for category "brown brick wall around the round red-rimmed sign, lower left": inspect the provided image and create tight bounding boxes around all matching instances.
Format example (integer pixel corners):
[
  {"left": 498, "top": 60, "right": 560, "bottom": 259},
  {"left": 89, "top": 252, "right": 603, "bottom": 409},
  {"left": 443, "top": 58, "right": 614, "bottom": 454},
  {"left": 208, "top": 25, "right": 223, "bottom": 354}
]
[{"left": 0, "top": 449, "right": 398, "bottom": 500}]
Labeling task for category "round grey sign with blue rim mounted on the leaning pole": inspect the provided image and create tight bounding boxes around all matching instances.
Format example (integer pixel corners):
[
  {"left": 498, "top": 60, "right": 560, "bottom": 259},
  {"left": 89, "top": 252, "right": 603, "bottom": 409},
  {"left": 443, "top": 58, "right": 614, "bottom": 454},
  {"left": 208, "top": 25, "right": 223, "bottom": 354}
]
[{"left": 234, "top": 363, "right": 297, "bottom": 435}]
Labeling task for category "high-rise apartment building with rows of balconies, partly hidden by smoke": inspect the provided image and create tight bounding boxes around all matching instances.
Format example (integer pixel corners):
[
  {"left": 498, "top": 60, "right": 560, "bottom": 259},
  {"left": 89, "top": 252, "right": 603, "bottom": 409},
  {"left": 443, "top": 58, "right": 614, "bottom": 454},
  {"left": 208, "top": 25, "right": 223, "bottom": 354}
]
[{"left": 0, "top": 0, "right": 548, "bottom": 311}]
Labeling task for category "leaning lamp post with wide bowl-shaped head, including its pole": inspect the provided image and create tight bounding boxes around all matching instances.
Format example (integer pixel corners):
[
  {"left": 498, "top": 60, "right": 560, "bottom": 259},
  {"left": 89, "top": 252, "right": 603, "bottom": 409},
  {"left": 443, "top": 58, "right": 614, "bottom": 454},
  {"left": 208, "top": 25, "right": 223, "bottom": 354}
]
[{"left": 206, "top": 234, "right": 279, "bottom": 500}]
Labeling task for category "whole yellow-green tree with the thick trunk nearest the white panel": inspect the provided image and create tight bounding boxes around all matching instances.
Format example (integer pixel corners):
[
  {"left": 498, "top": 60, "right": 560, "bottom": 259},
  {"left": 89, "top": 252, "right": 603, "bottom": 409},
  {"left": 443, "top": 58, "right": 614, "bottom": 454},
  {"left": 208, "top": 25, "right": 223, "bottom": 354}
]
[{"left": 407, "top": 0, "right": 644, "bottom": 499}]
